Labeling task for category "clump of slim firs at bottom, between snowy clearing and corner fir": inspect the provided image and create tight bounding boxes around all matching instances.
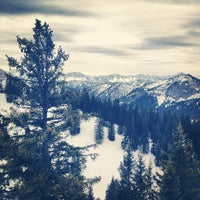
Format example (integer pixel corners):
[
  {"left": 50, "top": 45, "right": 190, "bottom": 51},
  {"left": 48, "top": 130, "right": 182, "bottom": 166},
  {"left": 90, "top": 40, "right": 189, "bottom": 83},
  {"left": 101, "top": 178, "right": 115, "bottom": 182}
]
[{"left": 106, "top": 145, "right": 159, "bottom": 200}]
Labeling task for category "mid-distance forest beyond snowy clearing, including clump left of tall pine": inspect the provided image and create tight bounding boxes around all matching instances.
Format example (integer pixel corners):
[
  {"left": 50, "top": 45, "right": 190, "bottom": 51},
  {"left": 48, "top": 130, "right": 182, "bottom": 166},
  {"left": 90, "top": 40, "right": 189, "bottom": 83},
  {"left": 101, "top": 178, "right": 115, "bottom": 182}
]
[{"left": 5, "top": 56, "right": 200, "bottom": 164}]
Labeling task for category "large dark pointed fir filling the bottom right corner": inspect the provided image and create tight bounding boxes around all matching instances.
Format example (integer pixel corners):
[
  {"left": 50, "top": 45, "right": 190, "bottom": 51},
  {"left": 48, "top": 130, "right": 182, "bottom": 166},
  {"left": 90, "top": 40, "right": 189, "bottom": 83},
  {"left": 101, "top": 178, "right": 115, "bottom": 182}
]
[{"left": 160, "top": 124, "right": 200, "bottom": 200}]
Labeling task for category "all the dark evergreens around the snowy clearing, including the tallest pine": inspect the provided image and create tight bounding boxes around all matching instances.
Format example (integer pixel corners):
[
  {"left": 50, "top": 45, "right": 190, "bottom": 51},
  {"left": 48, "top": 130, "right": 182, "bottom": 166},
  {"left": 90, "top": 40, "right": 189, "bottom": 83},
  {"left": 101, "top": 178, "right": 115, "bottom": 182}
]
[{"left": 0, "top": 19, "right": 200, "bottom": 200}]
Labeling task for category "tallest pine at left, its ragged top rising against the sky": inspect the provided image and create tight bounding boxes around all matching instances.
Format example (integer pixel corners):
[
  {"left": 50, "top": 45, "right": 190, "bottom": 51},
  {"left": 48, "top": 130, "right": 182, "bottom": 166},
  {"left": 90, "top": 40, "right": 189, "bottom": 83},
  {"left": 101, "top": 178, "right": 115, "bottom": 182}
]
[{"left": 1, "top": 19, "right": 87, "bottom": 200}]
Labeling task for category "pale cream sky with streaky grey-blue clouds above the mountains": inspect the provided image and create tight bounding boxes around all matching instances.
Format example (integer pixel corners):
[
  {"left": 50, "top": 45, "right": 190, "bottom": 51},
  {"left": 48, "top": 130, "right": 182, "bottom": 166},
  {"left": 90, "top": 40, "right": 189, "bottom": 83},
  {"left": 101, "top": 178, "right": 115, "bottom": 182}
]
[{"left": 0, "top": 0, "right": 200, "bottom": 77}]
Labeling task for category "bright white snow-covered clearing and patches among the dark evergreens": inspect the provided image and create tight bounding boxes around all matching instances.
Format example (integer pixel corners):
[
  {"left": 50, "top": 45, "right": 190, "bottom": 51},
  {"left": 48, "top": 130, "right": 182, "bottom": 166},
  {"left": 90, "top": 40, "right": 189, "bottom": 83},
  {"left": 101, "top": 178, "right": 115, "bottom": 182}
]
[{"left": 0, "top": 94, "right": 160, "bottom": 200}]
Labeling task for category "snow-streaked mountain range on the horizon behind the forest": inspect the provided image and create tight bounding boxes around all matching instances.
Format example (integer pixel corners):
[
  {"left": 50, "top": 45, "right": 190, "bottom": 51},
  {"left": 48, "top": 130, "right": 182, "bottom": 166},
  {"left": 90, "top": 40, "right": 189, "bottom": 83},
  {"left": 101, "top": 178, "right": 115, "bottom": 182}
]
[{"left": 65, "top": 73, "right": 200, "bottom": 118}]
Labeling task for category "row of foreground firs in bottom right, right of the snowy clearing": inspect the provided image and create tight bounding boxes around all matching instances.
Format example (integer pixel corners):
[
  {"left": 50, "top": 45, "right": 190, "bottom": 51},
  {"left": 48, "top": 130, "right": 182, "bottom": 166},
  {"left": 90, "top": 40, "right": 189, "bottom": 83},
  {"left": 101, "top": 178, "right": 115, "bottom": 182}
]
[{"left": 106, "top": 124, "right": 200, "bottom": 200}]
